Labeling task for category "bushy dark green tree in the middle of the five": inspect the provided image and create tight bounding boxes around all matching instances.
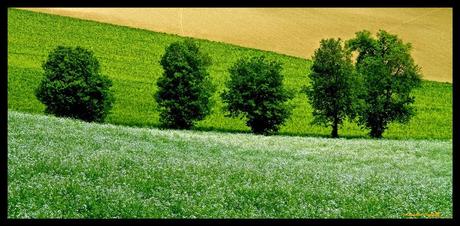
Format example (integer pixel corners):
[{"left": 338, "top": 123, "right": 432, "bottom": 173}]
[{"left": 221, "top": 56, "right": 293, "bottom": 135}]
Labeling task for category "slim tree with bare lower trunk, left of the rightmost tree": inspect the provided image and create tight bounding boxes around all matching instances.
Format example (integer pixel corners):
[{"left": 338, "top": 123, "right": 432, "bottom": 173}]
[{"left": 304, "top": 39, "right": 357, "bottom": 138}]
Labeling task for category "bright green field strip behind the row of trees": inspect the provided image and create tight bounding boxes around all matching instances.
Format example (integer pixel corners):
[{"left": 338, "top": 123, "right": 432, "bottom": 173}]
[{"left": 8, "top": 9, "right": 452, "bottom": 139}]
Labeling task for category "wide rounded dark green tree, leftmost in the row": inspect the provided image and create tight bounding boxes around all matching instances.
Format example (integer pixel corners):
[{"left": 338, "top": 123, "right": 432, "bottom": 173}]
[{"left": 35, "top": 46, "right": 114, "bottom": 122}]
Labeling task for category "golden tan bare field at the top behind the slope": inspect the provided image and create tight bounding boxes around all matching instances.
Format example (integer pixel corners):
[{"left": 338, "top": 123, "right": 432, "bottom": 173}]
[{"left": 20, "top": 8, "right": 453, "bottom": 82}]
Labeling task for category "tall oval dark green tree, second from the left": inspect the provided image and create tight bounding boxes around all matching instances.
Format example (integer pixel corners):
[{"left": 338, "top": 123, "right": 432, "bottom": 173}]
[{"left": 155, "top": 40, "right": 215, "bottom": 129}]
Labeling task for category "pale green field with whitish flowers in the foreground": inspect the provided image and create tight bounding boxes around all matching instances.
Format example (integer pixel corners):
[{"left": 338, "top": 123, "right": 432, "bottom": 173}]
[{"left": 8, "top": 111, "right": 452, "bottom": 218}]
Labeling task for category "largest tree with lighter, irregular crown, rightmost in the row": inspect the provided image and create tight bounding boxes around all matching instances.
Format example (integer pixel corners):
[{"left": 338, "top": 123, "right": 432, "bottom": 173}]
[{"left": 347, "top": 30, "right": 421, "bottom": 138}]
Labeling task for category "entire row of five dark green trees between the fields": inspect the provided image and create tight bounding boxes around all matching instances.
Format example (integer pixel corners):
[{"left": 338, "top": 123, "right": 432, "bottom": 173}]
[{"left": 35, "top": 30, "right": 421, "bottom": 138}]
